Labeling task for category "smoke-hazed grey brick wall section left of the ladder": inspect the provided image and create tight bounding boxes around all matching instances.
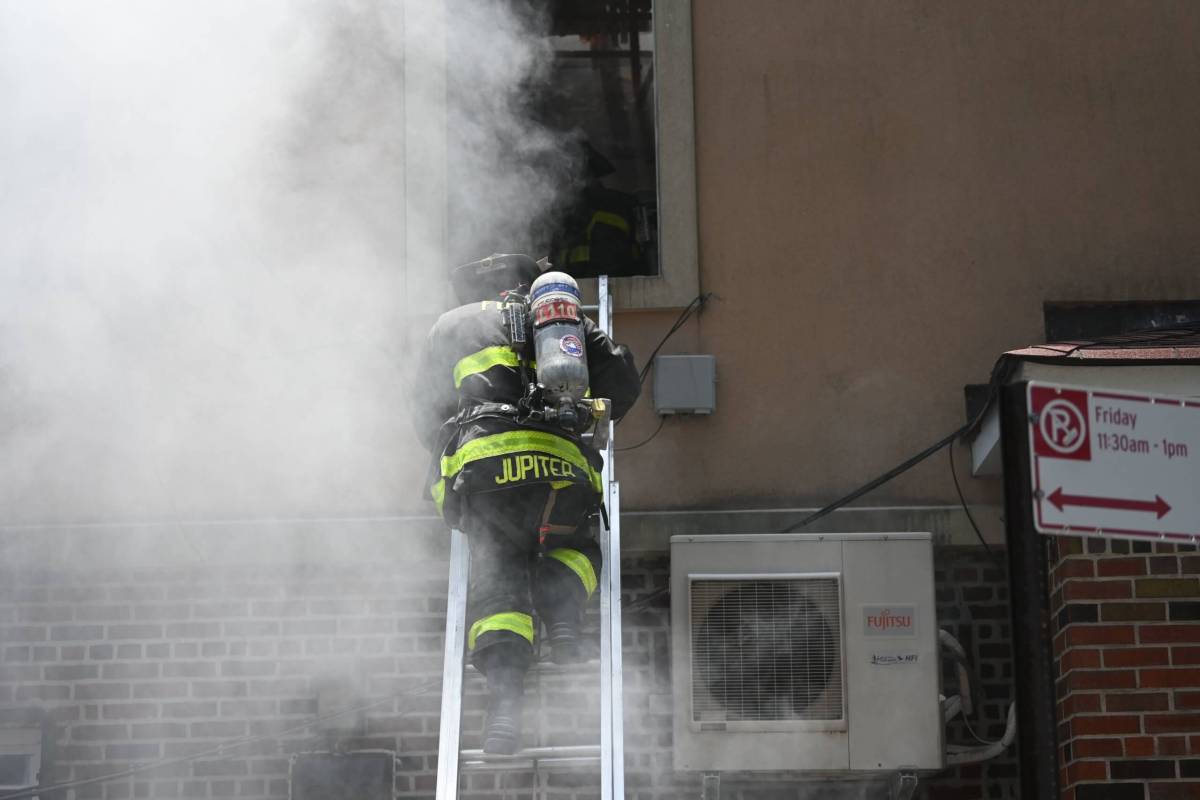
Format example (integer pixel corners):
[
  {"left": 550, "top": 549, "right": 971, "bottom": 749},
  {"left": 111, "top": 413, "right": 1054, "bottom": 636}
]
[{"left": 0, "top": 565, "right": 445, "bottom": 799}]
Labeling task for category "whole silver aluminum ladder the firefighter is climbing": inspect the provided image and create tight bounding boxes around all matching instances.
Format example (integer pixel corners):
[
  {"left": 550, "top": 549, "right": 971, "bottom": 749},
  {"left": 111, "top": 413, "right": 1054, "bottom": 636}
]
[{"left": 437, "top": 276, "right": 625, "bottom": 800}]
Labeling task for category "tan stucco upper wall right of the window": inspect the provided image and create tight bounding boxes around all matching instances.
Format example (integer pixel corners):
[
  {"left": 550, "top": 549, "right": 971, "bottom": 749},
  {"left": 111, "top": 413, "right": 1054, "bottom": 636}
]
[{"left": 604, "top": 0, "right": 1200, "bottom": 509}]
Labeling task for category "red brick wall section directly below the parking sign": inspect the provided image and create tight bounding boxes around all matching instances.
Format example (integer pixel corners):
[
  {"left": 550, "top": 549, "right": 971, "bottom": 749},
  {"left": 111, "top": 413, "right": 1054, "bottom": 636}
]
[{"left": 1049, "top": 537, "right": 1200, "bottom": 800}]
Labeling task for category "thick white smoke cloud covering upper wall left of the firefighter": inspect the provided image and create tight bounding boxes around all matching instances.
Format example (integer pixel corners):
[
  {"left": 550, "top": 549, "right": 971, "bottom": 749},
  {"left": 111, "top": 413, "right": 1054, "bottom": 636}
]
[{"left": 0, "top": 0, "right": 570, "bottom": 523}]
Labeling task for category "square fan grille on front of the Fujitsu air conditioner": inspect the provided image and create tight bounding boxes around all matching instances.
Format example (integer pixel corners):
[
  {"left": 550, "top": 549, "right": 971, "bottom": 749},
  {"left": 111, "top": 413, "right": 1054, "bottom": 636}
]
[{"left": 691, "top": 577, "right": 844, "bottom": 722}]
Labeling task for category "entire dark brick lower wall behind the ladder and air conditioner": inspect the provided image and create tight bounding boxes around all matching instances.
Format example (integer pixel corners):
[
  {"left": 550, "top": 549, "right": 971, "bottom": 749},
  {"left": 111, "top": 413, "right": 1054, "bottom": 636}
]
[{"left": 0, "top": 548, "right": 1016, "bottom": 800}]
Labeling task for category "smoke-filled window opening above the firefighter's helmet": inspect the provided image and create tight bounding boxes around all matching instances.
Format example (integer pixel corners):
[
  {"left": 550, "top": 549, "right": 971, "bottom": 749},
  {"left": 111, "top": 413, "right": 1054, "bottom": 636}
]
[{"left": 448, "top": 0, "right": 660, "bottom": 277}]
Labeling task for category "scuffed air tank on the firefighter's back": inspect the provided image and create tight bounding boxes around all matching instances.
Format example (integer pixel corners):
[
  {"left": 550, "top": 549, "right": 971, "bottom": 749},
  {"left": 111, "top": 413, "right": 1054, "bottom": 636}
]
[{"left": 529, "top": 272, "right": 588, "bottom": 427}]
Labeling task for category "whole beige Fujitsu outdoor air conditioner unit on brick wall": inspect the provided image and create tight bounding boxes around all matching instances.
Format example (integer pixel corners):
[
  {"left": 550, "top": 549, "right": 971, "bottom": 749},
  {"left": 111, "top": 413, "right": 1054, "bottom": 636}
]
[{"left": 671, "top": 534, "right": 943, "bottom": 772}]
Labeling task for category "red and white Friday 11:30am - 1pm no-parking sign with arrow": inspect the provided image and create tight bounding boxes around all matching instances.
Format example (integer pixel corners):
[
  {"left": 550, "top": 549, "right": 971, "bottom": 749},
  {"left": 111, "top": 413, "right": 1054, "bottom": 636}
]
[{"left": 1027, "top": 381, "right": 1200, "bottom": 542}]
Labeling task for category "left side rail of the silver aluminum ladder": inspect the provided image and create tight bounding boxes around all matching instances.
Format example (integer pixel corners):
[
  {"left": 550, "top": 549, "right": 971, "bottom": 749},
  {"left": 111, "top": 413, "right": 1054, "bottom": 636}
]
[{"left": 437, "top": 528, "right": 470, "bottom": 800}]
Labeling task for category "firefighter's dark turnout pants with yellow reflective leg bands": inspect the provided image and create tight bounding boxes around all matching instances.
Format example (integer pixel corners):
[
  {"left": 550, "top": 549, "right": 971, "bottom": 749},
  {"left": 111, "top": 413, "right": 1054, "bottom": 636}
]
[{"left": 461, "top": 483, "right": 600, "bottom": 674}]
